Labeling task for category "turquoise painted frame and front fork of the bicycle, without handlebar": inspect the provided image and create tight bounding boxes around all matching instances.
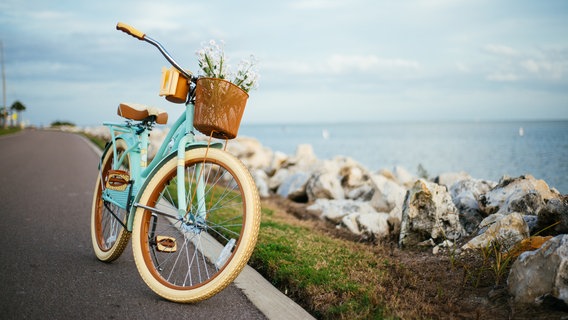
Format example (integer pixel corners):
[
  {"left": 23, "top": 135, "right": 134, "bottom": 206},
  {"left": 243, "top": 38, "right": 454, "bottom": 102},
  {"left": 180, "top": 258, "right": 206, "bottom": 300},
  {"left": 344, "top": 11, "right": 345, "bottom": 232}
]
[{"left": 99, "top": 102, "right": 222, "bottom": 231}]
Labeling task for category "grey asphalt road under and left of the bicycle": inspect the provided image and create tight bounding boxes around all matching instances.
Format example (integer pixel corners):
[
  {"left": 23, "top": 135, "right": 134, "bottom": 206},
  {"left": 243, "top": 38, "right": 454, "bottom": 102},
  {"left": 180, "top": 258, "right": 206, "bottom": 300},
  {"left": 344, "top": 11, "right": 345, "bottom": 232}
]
[{"left": 0, "top": 131, "right": 265, "bottom": 319}]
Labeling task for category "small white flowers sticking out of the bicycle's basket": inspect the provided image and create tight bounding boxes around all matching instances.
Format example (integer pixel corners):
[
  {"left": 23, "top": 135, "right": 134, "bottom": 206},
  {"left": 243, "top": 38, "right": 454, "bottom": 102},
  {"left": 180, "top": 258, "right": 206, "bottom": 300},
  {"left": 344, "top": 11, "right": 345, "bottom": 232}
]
[{"left": 196, "top": 40, "right": 259, "bottom": 92}]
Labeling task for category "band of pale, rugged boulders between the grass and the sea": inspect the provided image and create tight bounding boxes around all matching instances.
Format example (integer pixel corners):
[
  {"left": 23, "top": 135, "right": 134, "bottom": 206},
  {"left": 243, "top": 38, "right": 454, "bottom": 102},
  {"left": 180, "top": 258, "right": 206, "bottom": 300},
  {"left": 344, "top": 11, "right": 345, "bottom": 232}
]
[{"left": 88, "top": 129, "right": 568, "bottom": 310}]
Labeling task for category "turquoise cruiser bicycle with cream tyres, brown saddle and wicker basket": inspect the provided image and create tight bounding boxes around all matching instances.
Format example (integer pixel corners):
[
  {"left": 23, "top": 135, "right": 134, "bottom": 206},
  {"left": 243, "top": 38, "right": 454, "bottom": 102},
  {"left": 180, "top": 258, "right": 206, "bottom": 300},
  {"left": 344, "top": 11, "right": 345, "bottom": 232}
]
[{"left": 91, "top": 23, "right": 260, "bottom": 303}]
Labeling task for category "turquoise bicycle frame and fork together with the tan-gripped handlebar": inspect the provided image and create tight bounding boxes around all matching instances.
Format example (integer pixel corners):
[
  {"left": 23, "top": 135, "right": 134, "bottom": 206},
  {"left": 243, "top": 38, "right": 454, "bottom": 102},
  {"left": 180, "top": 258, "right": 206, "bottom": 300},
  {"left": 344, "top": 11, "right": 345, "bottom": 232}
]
[{"left": 99, "top": 23, "right": 233, "bottom": 231}]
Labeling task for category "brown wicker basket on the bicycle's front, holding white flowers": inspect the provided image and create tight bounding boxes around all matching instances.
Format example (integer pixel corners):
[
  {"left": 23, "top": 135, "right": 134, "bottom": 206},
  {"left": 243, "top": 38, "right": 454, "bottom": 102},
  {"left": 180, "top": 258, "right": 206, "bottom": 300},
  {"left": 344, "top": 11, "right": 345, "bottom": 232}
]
[{"left": 193, "top": 78, "right": 248, "bottom": 139}]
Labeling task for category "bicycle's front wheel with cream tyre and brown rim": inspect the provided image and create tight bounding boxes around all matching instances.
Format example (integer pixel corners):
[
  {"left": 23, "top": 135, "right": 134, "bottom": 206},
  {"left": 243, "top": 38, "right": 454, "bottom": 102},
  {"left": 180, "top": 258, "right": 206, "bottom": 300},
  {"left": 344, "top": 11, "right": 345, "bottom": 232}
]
[{"left": 132, "top": 148, "right": 260, "bottom": 303}]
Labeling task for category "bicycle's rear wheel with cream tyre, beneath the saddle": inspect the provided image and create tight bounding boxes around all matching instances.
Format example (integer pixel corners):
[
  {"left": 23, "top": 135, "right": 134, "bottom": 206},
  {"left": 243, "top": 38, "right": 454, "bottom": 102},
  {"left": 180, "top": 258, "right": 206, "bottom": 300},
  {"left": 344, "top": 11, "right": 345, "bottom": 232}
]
[{"left": 91, "top": 139, "right": 130, "bottom": 262}]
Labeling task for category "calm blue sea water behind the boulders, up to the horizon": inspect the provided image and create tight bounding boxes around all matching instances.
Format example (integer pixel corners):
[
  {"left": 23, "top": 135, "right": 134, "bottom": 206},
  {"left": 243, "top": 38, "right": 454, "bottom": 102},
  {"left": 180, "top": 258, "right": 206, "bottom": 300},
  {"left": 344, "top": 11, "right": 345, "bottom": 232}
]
[{"left": 239, "top": 121, "right": 568, "bottom": 194}]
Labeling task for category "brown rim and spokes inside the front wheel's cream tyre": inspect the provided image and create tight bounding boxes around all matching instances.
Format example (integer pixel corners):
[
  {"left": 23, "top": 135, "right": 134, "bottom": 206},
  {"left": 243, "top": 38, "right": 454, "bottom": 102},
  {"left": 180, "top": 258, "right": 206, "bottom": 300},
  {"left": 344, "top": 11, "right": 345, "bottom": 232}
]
[{"left": 140, "top": 159, "right": 246, "bottom": 290}]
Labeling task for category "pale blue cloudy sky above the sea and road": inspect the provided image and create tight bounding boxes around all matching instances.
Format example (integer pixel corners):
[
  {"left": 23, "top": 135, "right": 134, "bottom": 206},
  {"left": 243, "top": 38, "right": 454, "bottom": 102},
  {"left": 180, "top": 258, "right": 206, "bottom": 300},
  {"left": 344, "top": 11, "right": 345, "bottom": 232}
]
[{"left": 0, "top": 0, "right": 568, "bottom": 126}]
